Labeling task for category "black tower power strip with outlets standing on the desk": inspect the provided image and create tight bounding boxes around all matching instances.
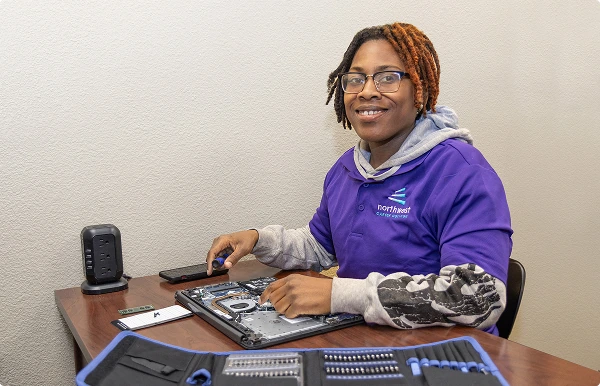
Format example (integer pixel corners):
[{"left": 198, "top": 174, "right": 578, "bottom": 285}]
[{"left": 81, "top": 224, "right": 128, "bottom": 295}]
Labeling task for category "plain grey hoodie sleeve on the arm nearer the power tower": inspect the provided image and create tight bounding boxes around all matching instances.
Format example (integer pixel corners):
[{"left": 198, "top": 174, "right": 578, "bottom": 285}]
[{"left": 252, "top": 225, "right": 337, "bottom": 272}]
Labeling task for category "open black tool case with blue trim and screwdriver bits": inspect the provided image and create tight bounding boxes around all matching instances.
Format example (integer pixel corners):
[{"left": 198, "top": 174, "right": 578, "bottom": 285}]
[{"left": 75, "top": 331, "right": 508, "bottom": 386}]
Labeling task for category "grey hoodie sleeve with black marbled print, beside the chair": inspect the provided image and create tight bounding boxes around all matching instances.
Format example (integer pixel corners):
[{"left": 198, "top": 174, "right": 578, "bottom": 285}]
[{"left": 331, "top": 264, "right": 506, "bottom": 329}]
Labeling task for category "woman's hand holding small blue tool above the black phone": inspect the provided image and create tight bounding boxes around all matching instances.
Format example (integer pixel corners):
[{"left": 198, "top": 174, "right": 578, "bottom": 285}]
[{"left": 206, "top": 229, "right": 258, "bottom": 275}]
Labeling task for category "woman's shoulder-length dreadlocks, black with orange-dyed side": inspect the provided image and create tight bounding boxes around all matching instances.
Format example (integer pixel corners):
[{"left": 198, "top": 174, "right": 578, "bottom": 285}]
[{"left": 325, "top": 23, "right": 440, "bottom": 129}]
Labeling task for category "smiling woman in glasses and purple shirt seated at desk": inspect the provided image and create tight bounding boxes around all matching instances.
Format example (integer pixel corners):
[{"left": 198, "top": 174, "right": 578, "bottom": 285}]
[{"left": 206, "top": 23, "right": 512, "bottom": 335}]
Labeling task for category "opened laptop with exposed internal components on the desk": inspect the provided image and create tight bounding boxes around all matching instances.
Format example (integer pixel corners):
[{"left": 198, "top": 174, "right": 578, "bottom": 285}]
[{"left": 175, "top": 277, "right": 363, "bottom": 349}]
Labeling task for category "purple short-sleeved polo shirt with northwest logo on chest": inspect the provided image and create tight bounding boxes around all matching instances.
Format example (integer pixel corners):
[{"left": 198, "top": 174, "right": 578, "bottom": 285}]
[{"left": 309, "top": 139, "right": 512, "bottom": 283}]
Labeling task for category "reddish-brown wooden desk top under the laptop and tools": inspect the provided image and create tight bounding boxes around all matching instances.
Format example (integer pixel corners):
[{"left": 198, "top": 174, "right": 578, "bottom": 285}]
[{"left": 55, "top": 260, "right": 600, "bottom": 386}]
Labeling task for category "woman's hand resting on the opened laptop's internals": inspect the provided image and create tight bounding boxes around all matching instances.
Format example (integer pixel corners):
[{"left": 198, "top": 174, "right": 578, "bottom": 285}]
[{"left": 260, "top": 274, "right": 333, "bottom": 318}]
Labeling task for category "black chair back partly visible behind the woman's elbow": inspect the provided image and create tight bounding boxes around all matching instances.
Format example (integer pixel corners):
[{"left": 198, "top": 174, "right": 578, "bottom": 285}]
[{"left": 496, "top": 259, "right": 525, "bottom": 339}]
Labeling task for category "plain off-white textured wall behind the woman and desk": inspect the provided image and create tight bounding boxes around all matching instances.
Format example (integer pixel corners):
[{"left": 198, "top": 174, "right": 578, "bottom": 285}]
[{"left": 0, "top": 0, "right": 600, "bottom": 386}]
